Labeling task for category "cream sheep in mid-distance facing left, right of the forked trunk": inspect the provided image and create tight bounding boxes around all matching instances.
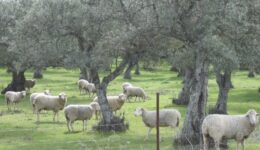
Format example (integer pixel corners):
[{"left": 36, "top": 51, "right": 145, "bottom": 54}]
[{"left": 125, "top": 86, "right": 146, "bottom": 102}]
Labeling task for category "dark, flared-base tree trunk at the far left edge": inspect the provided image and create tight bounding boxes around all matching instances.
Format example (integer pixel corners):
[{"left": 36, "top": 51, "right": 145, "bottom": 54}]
[{"left": 1, "top": 70, "right": 25, "bottom": 94}]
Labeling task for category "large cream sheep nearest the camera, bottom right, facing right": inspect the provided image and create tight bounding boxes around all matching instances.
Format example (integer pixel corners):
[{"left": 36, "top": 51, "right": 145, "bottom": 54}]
[{"left": 201, "top": 109, "right": 260, "bottom": 150}]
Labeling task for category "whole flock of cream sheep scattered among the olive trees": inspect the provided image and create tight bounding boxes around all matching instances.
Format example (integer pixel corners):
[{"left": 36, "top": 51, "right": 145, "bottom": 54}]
[{"left": 2, "top": 79, "right": 260, "bottom": 150}]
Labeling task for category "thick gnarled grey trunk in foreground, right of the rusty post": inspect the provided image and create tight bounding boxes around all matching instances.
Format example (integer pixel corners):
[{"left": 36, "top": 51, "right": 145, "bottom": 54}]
[{"left": 174, "top": 51, "right": 208, "bottom": 145}]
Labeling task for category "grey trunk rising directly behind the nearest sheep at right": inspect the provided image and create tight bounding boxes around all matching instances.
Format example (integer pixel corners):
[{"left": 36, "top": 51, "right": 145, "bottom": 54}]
[{"left": 210, "top": 70, "right": 232, "bottom": 114}]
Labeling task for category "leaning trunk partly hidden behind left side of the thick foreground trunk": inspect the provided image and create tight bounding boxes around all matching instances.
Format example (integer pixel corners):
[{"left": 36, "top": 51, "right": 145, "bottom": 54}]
[{"left": 173, "top": 68, "right": 194, "bottom": 105}]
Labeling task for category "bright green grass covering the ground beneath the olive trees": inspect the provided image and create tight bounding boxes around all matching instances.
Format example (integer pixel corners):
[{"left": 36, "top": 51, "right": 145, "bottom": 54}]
[{"left": 0, "top": 65, "right": 260, "bottom": 150}]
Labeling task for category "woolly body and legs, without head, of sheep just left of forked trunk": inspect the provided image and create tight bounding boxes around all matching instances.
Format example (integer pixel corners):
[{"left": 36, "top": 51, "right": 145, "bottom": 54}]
[{"left": 64, "top": 105, "right": 93, "bottom": 132}]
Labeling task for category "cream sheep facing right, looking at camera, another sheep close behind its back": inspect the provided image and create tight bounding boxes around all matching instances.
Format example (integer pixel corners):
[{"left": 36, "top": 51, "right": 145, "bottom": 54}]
[{"left": 33, "top": 92, "right": 67, "bottom": 122}]
